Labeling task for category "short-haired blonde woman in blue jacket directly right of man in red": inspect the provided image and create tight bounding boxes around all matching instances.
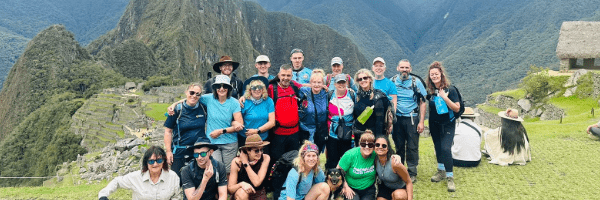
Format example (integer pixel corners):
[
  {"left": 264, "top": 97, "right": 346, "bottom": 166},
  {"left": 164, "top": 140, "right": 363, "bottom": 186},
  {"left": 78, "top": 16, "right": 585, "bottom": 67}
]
[{"left": 300, "top": 69, "right": 329, "bottom": 150}]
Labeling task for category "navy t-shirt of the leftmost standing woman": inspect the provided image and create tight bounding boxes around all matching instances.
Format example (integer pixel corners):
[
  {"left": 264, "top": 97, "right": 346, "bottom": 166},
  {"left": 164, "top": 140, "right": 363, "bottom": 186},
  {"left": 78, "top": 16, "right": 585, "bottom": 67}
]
[{"left": 164, "top": 101, "right": 208, "bottom": 158}]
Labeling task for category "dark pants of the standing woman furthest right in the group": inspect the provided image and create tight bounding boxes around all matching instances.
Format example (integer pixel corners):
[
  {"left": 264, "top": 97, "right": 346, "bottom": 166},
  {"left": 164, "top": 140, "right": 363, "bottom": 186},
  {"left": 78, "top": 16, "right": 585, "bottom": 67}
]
[{"left": 429, "top": 120, "right": 456, "bottom": 172}]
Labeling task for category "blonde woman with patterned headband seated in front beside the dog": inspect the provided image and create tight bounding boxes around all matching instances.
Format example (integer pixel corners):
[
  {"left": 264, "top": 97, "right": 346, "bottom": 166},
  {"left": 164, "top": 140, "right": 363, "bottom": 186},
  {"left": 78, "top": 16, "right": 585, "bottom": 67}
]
[{"left": 279, "top": 141, "right": 330, "bottom": 200}]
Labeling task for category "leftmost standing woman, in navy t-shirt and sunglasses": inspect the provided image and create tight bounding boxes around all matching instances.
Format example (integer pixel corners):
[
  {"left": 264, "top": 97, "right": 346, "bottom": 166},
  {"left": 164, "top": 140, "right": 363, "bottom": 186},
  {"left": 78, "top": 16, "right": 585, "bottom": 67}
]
[{"left": 164, "top": 84, "right": 208, "bottom": 180}]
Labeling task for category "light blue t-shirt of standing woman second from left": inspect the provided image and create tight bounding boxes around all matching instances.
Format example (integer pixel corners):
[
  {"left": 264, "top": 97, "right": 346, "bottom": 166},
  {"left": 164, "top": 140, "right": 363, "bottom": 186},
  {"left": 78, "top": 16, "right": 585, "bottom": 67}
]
[{"left": 200, "top": 93, "right": 242, "bottom": 144}]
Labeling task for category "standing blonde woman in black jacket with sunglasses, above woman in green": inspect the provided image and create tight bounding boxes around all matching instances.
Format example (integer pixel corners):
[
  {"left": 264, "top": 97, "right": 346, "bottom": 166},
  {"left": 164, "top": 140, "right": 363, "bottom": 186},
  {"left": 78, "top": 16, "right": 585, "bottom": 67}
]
[{"left": 353, "top": 69, "right": 390, "bottom": 142}]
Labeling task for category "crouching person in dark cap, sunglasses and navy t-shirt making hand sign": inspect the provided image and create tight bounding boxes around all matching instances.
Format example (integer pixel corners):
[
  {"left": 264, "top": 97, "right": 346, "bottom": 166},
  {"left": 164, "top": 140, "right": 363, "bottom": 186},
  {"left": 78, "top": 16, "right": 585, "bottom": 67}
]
[{"left": 181, "top": 142, "right": 227, "bottom": 200}]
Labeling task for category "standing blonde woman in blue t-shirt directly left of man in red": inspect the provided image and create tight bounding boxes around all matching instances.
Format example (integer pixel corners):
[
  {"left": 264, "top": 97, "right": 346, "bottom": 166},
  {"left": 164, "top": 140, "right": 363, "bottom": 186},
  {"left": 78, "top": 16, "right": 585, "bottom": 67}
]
[{"left": 238, "top": 76, "right": 275, "bottom": 147}]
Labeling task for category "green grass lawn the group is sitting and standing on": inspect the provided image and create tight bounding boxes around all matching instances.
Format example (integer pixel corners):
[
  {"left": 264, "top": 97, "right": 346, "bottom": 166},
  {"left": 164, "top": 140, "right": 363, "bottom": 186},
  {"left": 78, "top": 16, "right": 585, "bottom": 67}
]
[{"left": 0, "top": 97, "right": 600, "bottom": 199}]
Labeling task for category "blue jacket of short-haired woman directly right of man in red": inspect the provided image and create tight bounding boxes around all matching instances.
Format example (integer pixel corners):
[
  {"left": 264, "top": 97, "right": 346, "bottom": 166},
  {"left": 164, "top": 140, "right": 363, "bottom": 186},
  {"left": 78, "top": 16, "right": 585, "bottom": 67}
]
[{"left": 299, "top": 87, "right": 328, "bottom": 134}]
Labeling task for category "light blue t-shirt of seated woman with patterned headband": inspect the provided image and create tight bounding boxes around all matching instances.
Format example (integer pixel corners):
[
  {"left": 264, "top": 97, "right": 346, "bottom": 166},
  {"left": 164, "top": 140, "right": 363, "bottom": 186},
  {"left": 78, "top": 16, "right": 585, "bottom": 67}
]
[{"left": 279, "top": 167, "right": 325, "bottom": 200}]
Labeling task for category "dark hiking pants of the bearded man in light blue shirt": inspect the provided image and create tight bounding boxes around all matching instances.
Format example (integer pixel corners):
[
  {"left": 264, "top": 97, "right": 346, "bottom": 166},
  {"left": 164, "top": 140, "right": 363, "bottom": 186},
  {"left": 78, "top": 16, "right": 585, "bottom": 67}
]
[{"left": 392, "top": 116, "right": 419, "bottom": 176}]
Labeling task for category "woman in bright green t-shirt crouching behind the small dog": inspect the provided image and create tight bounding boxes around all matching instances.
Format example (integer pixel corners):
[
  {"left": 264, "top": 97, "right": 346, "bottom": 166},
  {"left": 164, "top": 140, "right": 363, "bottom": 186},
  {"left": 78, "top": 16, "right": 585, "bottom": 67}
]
[{"left": 337, "top": 129, "right": 377, "bottom": 200}]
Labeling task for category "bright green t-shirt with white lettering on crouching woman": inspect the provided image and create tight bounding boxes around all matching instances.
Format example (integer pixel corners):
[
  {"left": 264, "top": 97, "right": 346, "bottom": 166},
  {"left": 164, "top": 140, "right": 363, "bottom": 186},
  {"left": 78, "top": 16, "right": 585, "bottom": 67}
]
[{"left": 339, "top": 147, "right": 376, "bottom": 190}]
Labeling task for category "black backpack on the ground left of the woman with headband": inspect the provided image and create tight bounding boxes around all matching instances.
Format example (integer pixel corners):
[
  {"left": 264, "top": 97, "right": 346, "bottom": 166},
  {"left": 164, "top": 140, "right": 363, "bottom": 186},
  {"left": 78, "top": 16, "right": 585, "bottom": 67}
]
[{"left": 269, "top": 150, "right": 300, "bottom": 197}]
